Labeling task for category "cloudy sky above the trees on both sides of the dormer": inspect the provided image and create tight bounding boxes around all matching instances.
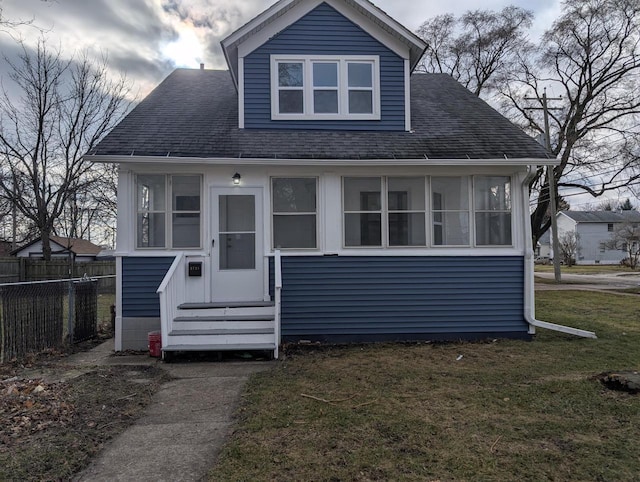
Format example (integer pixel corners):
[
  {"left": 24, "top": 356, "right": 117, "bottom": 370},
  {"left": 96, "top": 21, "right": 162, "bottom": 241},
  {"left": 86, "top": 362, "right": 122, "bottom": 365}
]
[{"left": 0, "top": 0, "right": 560, "bottom": 94}]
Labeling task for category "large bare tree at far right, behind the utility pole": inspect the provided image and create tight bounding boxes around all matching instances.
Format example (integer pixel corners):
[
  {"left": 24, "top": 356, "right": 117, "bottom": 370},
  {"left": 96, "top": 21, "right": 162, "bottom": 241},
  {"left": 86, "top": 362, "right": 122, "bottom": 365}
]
[{"left": 502, "top": 0, "right": 640, "bottom": 245}]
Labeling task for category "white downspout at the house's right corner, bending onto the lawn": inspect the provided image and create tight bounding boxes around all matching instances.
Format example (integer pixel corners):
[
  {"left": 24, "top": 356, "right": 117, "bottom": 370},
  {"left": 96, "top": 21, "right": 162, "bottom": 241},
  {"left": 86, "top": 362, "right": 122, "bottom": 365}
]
[{"left": 522, "top": 166, "right": 597, "bottom": 338}]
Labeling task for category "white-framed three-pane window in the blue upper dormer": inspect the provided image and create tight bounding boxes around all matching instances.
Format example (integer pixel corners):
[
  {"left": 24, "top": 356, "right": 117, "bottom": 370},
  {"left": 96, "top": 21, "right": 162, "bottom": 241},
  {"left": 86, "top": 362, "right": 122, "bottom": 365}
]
[{"left": 271, "top": 55, "right": 380, "bottom": 120}]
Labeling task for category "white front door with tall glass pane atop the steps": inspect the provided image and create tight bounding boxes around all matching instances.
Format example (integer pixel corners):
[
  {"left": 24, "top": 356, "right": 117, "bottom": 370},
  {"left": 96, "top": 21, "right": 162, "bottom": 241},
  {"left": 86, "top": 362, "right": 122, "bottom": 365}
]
[{"left": 211, "top": 187, "right": 264, "bottom": 302}]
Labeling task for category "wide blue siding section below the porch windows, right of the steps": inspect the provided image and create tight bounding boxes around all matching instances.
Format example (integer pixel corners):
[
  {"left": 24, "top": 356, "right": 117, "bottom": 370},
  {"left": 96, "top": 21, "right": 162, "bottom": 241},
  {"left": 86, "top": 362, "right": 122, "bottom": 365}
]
[{"left": 271, "top": 256, "right": 528, "bottom": 341}]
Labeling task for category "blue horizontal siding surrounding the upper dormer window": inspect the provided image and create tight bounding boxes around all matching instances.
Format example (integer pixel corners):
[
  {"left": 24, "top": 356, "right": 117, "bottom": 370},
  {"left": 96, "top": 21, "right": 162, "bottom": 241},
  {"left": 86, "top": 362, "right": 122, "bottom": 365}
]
[{"left": 244, "top": 3, "right": 405, "bottom": 131}]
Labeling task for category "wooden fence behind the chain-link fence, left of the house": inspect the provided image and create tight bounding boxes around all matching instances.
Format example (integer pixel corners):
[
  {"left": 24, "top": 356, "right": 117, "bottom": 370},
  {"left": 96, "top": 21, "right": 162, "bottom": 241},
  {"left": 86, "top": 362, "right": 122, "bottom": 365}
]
[{"left": 0, "top": 258, "right": 116, "bottom": 288}]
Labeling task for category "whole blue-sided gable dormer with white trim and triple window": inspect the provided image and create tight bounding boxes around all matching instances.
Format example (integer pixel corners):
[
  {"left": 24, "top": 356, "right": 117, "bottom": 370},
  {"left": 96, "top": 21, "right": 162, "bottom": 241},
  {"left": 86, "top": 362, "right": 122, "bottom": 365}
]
[{"left": 222, "top": 0, "right": 425, "bottom": 131}]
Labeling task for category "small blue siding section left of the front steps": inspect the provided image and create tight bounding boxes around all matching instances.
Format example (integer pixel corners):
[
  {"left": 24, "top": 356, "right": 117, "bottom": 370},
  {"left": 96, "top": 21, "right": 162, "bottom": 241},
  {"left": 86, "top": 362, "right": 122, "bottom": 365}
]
[{"left": 122, "top": 257, "right": 174, "bottom": 318}]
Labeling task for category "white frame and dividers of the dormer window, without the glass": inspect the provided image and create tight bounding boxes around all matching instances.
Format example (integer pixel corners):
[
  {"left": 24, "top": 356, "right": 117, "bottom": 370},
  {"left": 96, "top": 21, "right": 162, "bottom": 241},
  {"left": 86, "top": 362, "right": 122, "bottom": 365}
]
[{"left": 271, "top": 54, "right": 381, "bottom": 120}]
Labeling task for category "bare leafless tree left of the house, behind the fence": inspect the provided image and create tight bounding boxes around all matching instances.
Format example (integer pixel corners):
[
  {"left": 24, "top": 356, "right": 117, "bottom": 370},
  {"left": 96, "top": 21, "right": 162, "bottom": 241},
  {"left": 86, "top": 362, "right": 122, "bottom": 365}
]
[{"left": 0, "top": 38, "right": 129, "bottom": 259}]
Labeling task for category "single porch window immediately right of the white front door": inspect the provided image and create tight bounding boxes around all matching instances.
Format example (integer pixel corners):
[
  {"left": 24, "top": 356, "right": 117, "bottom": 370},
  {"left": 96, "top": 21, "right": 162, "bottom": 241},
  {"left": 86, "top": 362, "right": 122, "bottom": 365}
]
[{"left": 271, "top": 177, "right": 318, "bottom": 249}]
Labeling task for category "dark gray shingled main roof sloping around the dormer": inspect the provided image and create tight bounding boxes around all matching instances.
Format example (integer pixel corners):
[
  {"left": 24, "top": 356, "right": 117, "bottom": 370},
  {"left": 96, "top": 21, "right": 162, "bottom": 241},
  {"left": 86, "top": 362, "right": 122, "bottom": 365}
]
[{"left": 89, "top": 69, "right": 548, "bottom": 159}]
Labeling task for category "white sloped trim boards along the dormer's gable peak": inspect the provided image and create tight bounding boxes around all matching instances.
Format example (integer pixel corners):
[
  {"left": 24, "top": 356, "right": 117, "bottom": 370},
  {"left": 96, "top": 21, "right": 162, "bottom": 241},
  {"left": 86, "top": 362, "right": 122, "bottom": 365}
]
[{"left": 236, "top": 0, "right": 410, "bottom": 60}]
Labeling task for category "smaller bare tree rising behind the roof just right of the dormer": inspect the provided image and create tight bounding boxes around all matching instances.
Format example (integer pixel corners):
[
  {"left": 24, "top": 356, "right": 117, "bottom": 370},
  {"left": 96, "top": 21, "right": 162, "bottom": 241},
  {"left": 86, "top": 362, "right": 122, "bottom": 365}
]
[{"left": 417, "top": 6, "right": 533, "bottom": 95}]
